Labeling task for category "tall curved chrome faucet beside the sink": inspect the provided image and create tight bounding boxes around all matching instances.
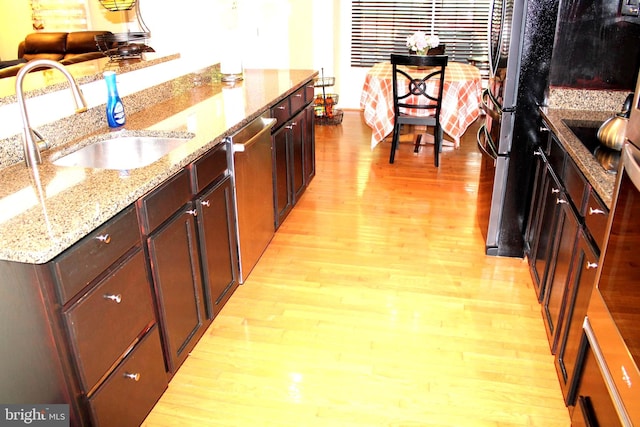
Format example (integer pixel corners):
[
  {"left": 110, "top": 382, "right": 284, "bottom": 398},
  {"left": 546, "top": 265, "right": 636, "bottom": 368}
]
[{"left": 16, "top": 59, "right": 87, "bottom": 167}]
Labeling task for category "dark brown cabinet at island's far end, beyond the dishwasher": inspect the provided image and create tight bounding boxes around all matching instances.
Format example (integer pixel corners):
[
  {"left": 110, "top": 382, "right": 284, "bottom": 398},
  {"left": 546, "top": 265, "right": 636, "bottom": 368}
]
[{"left": 271, "top": 82, "right": 315, "bottom": 229}]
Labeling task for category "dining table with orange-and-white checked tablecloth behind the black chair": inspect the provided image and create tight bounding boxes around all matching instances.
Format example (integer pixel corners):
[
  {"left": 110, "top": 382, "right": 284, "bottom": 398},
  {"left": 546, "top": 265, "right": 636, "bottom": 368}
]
[{"left": 360, "top": 61, "right": 482, "bottom": 149}]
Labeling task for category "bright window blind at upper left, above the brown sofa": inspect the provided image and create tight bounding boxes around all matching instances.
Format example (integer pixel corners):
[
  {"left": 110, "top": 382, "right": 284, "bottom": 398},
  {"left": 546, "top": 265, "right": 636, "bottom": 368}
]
[{"left": 31, "top": 0, "right": 88, "bottom": 32}]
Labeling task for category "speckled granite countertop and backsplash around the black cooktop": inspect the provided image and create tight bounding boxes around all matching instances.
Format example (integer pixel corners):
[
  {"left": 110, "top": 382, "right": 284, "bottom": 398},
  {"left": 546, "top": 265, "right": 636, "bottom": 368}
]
[{"left": 541, "top": 108, "right": 616, "bottom": 209}]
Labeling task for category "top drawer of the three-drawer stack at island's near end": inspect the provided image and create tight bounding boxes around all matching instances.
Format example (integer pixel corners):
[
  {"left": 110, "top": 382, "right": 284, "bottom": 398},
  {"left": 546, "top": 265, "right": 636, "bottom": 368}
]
[{"left": 52, "top": 206, "right": 140, "bottom": 304}]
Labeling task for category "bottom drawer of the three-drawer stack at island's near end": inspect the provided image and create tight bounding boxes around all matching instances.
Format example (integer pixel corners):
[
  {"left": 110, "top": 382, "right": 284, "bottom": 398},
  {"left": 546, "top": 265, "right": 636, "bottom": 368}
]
[{"left": 89, "top": 327, "right": 167, "bottom": 426}]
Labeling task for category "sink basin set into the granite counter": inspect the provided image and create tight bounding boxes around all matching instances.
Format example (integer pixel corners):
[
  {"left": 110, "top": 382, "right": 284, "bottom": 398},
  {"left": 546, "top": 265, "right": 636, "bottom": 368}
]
[{"left": 53, "top": 135, "right": 190, "bottom": 170}]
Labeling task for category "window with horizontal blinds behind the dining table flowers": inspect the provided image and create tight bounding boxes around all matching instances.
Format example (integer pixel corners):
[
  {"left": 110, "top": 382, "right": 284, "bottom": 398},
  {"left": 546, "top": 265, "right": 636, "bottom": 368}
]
[{"left": 351, "top": 0, "right": 491, "bottom": 73}]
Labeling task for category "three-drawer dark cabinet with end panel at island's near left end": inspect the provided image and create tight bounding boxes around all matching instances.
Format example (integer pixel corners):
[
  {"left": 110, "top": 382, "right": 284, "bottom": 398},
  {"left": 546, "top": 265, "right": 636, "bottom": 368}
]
[{"left": 0, "top": 206, "right": 167, "bottom": 426}]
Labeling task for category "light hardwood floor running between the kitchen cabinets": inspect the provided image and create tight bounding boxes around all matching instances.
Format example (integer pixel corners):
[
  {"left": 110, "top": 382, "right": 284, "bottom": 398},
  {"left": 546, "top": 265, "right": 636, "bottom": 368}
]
[{"left": 144, "top": 111, "right": 570, "bottom": 427}]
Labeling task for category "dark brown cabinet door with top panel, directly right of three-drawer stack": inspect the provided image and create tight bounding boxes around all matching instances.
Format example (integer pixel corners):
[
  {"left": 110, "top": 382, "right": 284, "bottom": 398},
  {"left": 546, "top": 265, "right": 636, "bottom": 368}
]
[{"left": 138, "top": 170, "right": 206, "bottom": 373}]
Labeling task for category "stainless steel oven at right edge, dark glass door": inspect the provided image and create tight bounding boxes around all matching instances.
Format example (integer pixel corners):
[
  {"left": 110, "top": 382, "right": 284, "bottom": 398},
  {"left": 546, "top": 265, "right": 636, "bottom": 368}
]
[{"left": 584, "top": 143, "right": 640, "bottom": 426}]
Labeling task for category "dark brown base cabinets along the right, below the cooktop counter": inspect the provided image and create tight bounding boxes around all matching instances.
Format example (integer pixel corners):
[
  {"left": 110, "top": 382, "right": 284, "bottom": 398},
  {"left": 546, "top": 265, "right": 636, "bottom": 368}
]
[{"left": 525, "top": 120, "right": 608, "bottom": 405}]
